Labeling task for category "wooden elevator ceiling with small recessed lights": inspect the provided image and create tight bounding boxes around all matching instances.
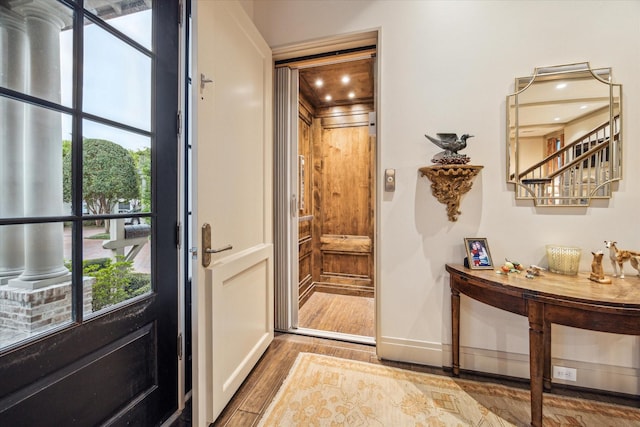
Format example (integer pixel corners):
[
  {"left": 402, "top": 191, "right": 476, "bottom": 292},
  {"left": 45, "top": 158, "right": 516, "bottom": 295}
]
[{"left": 299, "top": 57, "right": 375, "bottom": 108}]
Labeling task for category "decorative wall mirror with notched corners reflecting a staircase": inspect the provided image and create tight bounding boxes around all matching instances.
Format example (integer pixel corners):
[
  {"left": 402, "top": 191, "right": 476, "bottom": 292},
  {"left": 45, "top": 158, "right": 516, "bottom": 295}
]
[{"left": 506, "top": 62, "right": 622, "bottom": 206}]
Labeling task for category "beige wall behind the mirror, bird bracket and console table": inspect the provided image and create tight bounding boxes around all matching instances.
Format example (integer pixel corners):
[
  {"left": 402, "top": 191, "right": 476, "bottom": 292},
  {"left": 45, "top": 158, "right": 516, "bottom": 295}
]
[{"left": 253, "top": 0, "right": 640, "bottom": 393}]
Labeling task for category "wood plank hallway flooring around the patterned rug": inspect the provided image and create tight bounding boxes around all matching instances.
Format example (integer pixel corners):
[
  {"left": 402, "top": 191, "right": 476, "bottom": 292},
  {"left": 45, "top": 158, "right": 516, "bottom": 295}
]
[{"left": 172, "top": 333, "right": 640, "bottom": 427}]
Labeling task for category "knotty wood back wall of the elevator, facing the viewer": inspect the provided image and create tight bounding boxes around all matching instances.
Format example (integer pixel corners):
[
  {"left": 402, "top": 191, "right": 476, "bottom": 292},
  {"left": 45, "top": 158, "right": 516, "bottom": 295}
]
[{"left": 314, "top": 123, "right": 373, "bottom": 296}]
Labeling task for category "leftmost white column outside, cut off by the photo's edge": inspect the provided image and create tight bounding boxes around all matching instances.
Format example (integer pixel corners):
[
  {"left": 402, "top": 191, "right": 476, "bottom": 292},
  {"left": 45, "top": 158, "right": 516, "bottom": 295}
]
[{"left": 0, "top": 6, "right": 27, "bottom": 285}]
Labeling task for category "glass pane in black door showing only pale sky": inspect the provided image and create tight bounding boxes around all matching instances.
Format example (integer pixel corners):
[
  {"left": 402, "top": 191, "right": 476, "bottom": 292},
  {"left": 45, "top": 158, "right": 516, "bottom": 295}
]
[{"left": 83, "top": 17, "right": 151, "bottom": 131}]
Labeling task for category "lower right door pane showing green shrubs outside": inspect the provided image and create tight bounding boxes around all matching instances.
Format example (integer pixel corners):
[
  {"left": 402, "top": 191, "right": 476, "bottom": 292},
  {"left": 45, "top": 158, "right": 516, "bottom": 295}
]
[{"left": 82, "top": 218, "right": 151, "bottom": 317}]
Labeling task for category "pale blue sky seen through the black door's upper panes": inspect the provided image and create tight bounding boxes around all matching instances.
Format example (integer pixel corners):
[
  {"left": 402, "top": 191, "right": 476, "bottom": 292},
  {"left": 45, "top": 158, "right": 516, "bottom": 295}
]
[{"left": 60, "top": 10, "right": 152, "bottom": 150}]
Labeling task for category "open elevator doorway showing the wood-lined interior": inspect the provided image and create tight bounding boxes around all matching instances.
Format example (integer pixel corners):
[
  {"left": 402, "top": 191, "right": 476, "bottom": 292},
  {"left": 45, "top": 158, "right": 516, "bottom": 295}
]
[{"left": 276, "top": 36, "right": 377, "bottom": 344}]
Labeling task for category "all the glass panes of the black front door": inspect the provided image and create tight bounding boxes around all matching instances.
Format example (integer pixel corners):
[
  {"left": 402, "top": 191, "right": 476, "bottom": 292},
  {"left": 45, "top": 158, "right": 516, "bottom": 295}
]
[{"left": 0, "top": 0, "right": 152, "bottom": 351}]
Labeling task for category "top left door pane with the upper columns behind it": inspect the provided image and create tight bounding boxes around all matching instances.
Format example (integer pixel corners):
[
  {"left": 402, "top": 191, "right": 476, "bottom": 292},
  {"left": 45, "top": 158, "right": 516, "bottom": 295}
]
[{"left": 0, "top": 0, "right": 73, "bottom": 106}]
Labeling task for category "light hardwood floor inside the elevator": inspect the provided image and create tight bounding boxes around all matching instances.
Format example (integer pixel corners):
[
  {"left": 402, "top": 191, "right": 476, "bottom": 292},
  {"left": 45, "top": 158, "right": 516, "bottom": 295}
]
[{"left": 298, "top": 292, "right": 375, "bottom": 337}]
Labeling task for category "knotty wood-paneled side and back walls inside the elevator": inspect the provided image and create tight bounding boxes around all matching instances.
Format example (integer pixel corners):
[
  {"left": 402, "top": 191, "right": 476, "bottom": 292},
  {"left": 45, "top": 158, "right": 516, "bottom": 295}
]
[{"left": 298, "top": 100, "right": 375, "bottom": 305}]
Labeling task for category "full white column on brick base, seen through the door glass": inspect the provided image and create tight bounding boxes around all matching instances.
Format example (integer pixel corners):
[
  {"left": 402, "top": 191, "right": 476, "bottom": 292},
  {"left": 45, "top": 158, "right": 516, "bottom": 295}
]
[{"left": 9, "top": 3, "right": 70, "bottom": 289}]
